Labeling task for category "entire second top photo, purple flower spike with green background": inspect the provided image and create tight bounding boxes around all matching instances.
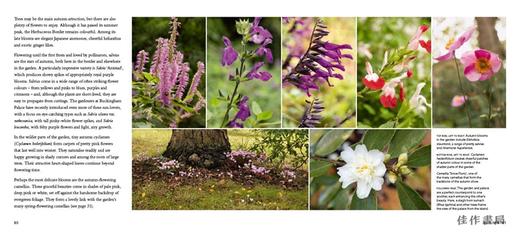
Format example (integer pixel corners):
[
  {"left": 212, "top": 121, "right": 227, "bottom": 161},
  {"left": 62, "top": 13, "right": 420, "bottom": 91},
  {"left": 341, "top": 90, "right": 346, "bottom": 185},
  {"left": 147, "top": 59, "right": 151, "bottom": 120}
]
[{"left": 207, "top": 18, "right": 280, "bottom": 128}]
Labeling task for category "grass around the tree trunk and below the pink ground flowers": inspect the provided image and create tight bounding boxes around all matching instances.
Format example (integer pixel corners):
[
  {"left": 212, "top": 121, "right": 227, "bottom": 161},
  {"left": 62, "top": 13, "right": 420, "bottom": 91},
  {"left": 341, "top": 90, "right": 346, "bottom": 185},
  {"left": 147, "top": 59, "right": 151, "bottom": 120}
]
[{"left": 132, "top": 129, "right": 308, "bottom": 210}]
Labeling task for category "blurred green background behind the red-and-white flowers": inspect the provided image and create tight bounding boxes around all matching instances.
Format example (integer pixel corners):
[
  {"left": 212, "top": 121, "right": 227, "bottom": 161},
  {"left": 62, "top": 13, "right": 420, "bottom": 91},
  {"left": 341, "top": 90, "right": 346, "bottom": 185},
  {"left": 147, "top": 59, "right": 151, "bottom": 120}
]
[{"left": 357, "top": 17, "right": 431, "bottom": 128}]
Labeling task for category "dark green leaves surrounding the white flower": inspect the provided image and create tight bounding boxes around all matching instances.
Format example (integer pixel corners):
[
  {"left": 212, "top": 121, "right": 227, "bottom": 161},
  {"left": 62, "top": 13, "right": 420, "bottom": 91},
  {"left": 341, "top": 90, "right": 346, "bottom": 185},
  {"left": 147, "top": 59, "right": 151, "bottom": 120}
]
[{"left": 310, "top": 129, "right": 431, "bottom": 210}]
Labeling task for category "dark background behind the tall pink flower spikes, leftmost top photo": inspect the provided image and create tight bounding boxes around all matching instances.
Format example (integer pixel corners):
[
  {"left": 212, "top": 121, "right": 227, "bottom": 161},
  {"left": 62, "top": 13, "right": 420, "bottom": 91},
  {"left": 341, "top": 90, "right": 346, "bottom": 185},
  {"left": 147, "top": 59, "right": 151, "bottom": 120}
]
[{"left": 132, "top": 17, "right": 206, "bottom": 128}]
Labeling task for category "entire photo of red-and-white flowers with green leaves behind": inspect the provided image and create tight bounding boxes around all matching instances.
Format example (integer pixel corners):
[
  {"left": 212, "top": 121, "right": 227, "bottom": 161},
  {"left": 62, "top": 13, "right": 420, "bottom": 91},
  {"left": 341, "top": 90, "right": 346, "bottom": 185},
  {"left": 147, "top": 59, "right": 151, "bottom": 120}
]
[{"left": 357, "top": 17, "right": 431, "bottom": 128}]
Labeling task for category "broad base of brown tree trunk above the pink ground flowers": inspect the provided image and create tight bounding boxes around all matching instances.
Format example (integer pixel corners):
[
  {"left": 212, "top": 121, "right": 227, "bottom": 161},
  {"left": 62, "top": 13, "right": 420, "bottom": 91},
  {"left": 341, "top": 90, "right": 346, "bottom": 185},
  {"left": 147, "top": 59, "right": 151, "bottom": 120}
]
[{"left": 162, "top": 130, "right": 231, "bottom": 168}]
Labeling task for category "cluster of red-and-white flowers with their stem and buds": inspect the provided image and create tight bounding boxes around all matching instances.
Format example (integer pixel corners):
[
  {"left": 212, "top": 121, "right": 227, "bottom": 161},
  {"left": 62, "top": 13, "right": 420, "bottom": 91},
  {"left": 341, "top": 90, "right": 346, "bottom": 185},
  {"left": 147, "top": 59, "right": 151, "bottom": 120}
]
[{"left": 362, "top": 25, "right": 431, "bottom": 114}]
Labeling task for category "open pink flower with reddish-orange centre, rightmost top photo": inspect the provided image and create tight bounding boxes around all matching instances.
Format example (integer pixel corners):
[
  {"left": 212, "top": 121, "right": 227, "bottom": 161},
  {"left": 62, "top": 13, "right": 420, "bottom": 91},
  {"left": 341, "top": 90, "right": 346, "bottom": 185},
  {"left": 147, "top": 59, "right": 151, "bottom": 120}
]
[{"left": 460, "top": 49, "right": 502, "bottom": 81}]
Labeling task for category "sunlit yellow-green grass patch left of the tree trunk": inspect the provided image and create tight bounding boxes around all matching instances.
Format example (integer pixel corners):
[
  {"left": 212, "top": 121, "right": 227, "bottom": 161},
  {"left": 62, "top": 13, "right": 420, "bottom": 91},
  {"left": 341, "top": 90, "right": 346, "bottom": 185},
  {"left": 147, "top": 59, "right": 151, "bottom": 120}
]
[{"left": 132, "top": 129, "right": 171, "bottom": 159}]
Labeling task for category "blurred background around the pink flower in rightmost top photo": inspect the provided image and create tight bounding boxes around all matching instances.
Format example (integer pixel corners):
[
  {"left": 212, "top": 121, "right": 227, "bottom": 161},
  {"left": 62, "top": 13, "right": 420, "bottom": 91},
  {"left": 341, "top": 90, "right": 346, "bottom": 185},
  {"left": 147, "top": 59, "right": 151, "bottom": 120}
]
[{"left": 432, "top": 18, "right": 506, "bottom": 128}]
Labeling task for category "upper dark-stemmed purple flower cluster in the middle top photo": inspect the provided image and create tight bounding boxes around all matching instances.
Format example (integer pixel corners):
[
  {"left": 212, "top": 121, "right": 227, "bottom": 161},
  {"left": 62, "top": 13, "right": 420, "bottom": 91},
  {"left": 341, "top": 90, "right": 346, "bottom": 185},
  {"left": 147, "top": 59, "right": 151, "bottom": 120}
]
[{"left": 283, "top": 19, "right": 353, "bottom": 96}]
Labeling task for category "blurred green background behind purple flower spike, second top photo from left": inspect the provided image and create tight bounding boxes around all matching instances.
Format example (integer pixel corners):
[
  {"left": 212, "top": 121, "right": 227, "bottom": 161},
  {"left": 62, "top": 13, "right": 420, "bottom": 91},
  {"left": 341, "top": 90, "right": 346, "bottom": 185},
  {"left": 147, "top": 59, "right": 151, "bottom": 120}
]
[{"left": 207, "top": 17, "right": 281, "bottom": 128}]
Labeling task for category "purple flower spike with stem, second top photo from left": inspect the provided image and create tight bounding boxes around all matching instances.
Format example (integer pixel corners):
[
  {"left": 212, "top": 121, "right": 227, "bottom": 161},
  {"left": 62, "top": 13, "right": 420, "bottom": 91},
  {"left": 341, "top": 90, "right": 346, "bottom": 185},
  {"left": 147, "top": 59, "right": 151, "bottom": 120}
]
[{"left": 220, "top": 17, "right": 273, "bottom": 128}]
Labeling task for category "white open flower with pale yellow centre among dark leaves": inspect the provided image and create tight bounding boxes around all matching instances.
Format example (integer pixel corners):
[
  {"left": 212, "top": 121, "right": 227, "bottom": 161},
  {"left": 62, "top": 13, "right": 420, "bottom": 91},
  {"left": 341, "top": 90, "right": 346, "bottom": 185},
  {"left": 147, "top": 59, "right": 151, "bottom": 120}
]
[{"left": 338, "top": 145, "right": 386, "bottom": 199}]
